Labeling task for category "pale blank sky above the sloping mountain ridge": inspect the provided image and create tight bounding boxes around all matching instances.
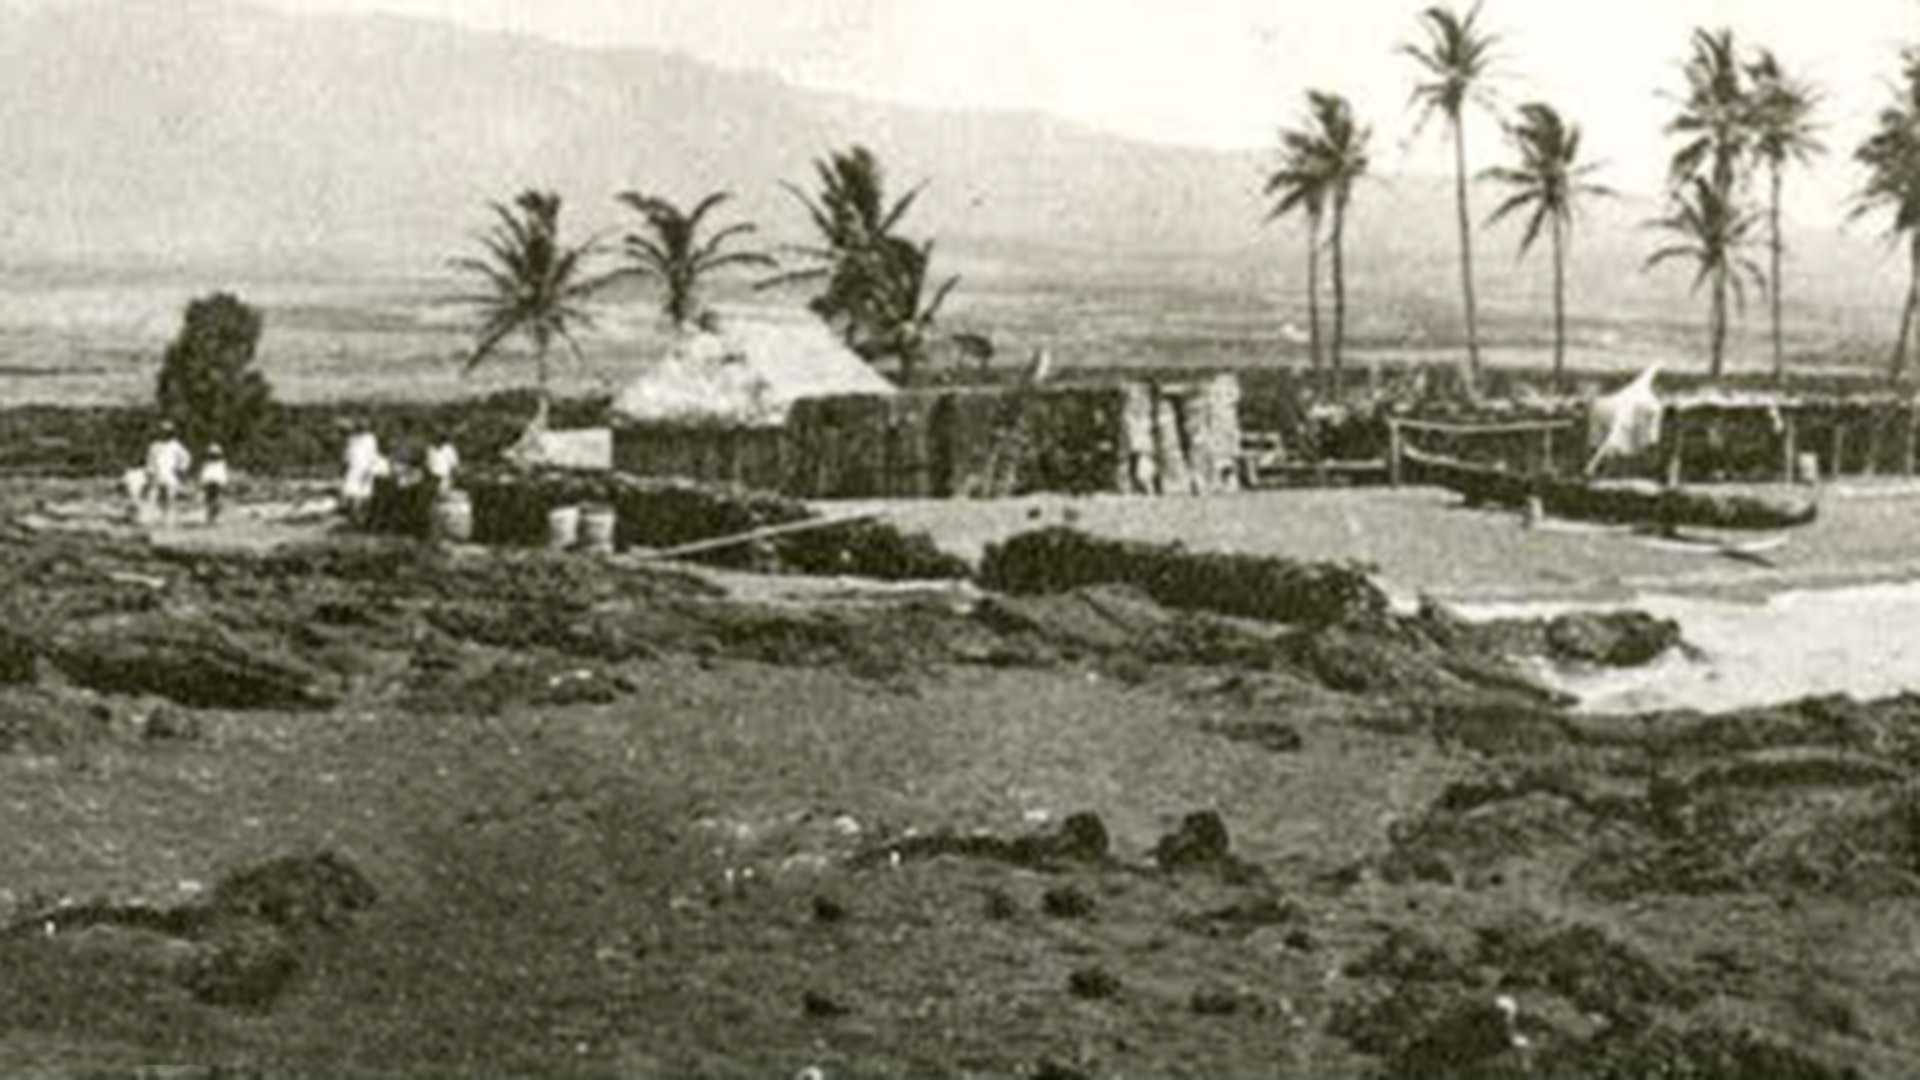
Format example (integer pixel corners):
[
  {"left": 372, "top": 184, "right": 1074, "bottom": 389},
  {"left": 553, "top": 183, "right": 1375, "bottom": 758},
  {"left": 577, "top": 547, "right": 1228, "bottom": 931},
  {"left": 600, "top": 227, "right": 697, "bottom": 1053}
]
[{"left": 255, "top": 0, "right": 1920, "bottom": 219}]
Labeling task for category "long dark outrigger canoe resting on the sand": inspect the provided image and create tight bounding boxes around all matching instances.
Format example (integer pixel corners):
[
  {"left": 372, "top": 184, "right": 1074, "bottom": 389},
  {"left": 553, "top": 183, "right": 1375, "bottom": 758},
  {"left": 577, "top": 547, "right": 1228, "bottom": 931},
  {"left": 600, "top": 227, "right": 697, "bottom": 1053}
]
[{"left": 1402, "top": 448, "right": 1820, "bottom": 530}]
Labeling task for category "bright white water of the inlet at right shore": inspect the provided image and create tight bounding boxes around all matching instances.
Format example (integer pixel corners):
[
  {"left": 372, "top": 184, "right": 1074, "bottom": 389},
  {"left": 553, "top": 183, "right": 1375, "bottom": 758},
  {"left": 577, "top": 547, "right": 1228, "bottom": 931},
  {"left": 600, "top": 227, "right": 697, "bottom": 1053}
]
[{"left": 1461, "top": 580, "right": 1920, "bottom": 715}]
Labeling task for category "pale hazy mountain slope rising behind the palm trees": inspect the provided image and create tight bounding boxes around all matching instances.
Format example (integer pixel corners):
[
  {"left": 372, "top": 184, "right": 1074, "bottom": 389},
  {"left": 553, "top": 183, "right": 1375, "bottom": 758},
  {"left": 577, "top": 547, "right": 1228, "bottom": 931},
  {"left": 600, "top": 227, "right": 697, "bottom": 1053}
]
[{"left": 0, "top": 0, "right": 1903, "bottom": 349}]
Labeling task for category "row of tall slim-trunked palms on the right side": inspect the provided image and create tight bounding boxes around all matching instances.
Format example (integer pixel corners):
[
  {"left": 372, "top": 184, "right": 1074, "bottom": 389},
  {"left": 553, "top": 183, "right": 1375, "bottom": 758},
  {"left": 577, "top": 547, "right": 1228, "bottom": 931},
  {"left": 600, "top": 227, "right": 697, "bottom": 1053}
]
[{"left": 1267, "top": 4, "right": 1843, "bottom": 388}]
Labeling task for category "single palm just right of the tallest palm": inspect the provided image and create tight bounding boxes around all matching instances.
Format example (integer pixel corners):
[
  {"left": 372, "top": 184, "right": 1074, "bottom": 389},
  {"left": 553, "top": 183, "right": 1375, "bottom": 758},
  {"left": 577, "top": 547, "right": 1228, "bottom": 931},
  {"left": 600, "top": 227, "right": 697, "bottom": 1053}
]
[{"left": 1482, "top": 102, "right": 1613, "bottom": 382}]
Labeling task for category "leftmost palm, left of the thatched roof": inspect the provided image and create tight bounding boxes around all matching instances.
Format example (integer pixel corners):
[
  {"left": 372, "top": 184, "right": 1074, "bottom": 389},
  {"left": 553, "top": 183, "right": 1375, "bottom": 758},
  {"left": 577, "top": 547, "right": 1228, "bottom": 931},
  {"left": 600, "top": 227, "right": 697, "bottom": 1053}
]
[{"left": 453, "top": 190, "right": 607, "bottom": 407}]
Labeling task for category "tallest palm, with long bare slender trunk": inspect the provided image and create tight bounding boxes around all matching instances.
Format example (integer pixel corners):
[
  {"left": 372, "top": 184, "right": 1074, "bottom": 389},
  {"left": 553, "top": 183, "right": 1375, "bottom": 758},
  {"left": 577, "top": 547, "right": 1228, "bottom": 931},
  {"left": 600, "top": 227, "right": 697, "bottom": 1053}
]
[{"left": 1400, "top": 4, "right": 1500, "bottom": 386}]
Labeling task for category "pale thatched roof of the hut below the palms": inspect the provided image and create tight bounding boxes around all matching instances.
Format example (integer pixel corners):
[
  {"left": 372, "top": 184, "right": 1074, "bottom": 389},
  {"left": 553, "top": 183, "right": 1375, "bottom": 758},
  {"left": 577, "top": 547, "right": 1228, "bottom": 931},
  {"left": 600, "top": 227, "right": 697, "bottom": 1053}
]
[{"left": 612, "top": 317, "right": 895, "bottom": 427}]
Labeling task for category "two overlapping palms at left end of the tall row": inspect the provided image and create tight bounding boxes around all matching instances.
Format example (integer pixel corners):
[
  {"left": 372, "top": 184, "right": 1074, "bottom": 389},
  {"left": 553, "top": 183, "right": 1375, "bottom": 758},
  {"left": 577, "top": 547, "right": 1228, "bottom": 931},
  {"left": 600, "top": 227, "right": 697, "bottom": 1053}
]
[{"left": 1267, "top": 90, "right": 1373, "bottom": 384}]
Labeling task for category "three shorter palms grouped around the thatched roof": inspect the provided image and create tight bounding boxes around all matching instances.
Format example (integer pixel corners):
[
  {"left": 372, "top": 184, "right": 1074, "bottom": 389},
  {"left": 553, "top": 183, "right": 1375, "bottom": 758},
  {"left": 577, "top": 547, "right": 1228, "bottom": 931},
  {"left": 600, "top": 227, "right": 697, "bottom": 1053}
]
[{"left": 453, "top": 146, "right": 960, "bottom": 402}]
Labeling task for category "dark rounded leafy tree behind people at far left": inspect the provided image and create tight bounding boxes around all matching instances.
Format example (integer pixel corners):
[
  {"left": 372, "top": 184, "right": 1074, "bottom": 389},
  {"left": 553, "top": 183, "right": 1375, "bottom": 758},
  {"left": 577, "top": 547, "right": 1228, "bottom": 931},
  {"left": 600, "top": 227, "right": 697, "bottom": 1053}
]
[{"left": 156, "top": 292, "right": 273, "bottom": 450}]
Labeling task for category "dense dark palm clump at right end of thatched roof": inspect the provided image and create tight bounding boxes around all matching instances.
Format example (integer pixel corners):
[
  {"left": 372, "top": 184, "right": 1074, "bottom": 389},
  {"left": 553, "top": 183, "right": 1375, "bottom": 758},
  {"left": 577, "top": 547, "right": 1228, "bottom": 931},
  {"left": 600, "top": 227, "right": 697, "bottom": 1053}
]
[{"left": 766, "top": 146, "right": 960, "bottom": 382}]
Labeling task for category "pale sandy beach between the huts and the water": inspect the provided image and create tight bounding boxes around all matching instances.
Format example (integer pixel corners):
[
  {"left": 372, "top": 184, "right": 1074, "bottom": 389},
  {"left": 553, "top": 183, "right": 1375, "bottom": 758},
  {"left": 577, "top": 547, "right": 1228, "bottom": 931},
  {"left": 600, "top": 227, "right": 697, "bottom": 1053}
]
[{"left": 824, "top": 480, "right": 1920, "bottom": 601}]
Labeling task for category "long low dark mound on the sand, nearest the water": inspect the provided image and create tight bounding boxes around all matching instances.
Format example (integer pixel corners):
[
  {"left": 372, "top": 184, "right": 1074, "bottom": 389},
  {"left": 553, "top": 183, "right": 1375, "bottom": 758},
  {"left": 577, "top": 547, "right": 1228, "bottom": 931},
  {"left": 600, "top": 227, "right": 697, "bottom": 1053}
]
[{"left": 981, "top": 527, "right": 1386, "bottom": 626}]
